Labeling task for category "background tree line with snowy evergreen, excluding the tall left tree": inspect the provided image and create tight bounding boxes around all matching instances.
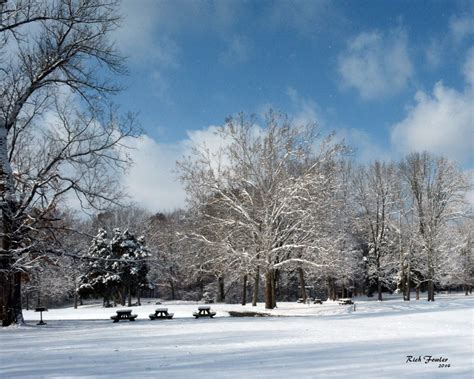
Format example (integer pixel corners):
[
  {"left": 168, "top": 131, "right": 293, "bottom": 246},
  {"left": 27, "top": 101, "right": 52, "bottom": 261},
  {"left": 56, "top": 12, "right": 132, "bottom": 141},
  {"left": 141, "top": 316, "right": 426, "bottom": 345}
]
[{"left": 23, "top": 116, "right": 474, "bottom": 318}]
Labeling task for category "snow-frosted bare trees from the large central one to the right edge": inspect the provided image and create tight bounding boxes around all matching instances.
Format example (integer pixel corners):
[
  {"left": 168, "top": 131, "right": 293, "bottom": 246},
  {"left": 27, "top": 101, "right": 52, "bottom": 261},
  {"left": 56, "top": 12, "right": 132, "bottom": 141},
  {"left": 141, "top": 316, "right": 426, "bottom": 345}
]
[{"left": 179, "top": 117, "right": 474, "bottom": 308}]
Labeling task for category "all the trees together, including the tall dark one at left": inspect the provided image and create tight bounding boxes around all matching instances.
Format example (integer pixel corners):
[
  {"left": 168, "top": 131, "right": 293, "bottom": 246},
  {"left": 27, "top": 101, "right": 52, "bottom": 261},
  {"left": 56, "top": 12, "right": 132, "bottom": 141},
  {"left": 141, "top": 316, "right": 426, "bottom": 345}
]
[{"left": 0, "top": 0, "right": 473, "bottom": 326}]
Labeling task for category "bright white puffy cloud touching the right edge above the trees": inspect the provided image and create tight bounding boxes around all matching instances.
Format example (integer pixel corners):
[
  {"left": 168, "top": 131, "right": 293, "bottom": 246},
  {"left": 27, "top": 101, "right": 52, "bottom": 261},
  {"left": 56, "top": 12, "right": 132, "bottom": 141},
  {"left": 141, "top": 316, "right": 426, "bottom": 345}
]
[{"left": 391, "top": 82, "right": 474, "bottom": 164}]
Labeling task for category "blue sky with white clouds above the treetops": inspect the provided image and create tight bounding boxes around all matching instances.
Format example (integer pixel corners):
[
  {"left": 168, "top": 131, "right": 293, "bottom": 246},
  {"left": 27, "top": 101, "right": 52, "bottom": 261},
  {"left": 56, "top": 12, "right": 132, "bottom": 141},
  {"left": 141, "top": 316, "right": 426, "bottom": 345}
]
[{"left": 115, "top": 0, "right": 474, "bottom": 210}]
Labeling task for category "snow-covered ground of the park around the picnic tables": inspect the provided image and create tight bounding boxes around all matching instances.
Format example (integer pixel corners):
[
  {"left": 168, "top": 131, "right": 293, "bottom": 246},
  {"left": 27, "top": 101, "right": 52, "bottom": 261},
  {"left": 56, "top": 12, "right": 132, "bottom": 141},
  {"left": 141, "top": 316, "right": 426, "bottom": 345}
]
[{"left": 0, "top": 294, "right": 474, "bottom": 378}]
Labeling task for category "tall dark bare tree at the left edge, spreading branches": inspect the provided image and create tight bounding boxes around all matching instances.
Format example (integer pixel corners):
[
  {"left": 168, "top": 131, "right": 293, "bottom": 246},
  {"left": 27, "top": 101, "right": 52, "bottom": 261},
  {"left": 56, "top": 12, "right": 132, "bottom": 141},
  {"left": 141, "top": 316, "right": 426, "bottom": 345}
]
[{"left": 0, "top": 0, "right": 133, "bottom": 325}]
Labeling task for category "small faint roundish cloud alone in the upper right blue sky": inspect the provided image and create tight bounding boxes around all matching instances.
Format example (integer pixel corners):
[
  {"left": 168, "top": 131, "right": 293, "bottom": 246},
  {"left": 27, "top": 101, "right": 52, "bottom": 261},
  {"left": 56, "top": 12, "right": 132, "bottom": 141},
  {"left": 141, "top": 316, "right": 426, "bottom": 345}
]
[{"left": 338, "top": 29, "right": 413, "bottom": 99}]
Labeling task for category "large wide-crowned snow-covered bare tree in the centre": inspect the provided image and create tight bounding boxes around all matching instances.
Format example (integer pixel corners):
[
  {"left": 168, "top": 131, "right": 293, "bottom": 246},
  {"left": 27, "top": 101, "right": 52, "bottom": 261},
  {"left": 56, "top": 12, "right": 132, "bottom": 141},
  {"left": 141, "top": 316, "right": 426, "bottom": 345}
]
[{"left": 179, "top": 112, "right": 341, "bottom": 308}]
